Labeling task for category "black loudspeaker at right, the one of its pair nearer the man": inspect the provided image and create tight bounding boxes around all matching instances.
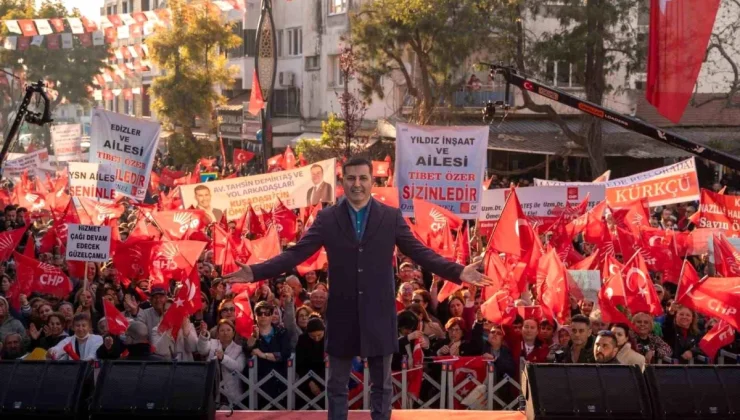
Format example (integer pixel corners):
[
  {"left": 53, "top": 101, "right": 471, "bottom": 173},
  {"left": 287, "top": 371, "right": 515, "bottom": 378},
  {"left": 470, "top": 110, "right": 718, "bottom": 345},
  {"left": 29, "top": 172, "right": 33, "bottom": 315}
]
[{"left": 522, "top": 363, "right": 652, "bottom": 420}]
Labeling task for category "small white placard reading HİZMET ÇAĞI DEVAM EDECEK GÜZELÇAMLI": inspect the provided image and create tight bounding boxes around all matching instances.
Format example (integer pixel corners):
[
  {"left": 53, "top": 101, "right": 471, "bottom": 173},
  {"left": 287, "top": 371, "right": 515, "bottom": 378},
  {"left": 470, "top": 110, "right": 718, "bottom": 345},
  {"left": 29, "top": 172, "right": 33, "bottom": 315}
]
[{"left": 67, "top": 223, "right": 111, "bottom": 263}]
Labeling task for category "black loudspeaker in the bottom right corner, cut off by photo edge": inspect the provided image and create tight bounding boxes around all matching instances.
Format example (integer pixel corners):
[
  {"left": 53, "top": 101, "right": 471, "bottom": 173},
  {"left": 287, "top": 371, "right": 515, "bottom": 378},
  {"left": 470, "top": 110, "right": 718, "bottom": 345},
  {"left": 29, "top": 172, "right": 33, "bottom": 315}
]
[{"left": 645, "top": 365, "right": 740, "bottom": 420}]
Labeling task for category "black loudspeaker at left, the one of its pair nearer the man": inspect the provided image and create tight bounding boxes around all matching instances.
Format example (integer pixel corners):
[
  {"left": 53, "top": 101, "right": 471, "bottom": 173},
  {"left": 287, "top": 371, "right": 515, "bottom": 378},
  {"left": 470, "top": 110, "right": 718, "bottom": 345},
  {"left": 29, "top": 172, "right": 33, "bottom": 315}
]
[{"left": 90, "top": 360, "right": 219, "bottom": 420}]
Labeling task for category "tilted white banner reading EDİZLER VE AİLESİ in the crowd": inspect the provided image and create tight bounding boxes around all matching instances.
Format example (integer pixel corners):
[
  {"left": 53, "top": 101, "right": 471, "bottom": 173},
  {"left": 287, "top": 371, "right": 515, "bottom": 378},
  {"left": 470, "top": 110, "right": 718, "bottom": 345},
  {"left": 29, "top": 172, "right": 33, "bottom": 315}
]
[{"left": 89, "top": 108, "right": 162, "bottom": 201}]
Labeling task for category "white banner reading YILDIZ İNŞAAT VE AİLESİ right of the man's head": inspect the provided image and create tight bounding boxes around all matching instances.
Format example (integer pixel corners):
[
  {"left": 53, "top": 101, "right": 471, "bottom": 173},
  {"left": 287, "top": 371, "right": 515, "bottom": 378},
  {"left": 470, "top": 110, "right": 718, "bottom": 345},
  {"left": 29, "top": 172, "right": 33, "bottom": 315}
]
[{"left": 394, "top": 123, "right": 489, "bottom": 219}]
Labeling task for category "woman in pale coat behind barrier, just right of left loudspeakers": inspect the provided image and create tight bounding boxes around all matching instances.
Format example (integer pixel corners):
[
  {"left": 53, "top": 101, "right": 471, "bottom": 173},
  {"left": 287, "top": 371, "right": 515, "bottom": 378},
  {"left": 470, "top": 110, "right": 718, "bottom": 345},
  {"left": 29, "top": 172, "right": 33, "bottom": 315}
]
[{"left": 198, "top": 319, "right": 246, "bottom": 405}]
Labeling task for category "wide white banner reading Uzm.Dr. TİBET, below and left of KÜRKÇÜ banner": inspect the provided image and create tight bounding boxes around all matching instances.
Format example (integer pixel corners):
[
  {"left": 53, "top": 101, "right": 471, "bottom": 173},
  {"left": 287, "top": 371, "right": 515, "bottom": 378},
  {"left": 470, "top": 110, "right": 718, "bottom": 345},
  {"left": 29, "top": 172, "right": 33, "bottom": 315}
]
[{"left": 478, "top": 184, "right": 606, "bottom": 234}]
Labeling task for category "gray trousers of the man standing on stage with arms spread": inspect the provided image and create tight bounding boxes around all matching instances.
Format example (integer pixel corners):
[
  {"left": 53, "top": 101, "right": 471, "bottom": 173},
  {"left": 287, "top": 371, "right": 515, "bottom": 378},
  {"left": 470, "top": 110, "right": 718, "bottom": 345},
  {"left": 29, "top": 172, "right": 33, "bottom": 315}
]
[{"left": 326, "top": 355, "right": 393, "bottom": 420}]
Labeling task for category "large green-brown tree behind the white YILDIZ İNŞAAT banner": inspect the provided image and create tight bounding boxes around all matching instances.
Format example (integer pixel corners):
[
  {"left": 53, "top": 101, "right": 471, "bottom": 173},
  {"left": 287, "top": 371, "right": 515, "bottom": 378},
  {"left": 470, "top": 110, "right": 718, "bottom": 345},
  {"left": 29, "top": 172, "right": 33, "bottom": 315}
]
[{"left": 350, "top": 0, "right": 500, "bottom": 124}]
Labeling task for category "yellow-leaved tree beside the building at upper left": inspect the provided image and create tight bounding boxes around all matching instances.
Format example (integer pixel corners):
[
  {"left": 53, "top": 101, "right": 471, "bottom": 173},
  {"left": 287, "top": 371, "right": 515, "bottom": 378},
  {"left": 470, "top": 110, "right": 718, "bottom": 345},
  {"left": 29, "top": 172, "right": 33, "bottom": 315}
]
[{"left": 147, "top": 0, "right": 241, "bottom": 141}]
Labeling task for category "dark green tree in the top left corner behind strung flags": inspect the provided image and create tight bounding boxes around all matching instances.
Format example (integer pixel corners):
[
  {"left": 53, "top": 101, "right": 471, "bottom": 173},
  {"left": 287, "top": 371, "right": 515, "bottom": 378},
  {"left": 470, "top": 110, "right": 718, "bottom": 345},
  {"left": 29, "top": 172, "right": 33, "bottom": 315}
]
[{"left": 0, "top": 0, "right": 108, "bottom": 147}]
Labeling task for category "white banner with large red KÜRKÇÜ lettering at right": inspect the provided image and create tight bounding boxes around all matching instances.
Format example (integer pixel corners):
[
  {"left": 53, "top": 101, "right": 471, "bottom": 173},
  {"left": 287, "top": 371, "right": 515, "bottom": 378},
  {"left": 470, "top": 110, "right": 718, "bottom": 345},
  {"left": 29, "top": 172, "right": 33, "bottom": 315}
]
[{"left": 534, "top": 157, "right": 699, "bottom": 208}]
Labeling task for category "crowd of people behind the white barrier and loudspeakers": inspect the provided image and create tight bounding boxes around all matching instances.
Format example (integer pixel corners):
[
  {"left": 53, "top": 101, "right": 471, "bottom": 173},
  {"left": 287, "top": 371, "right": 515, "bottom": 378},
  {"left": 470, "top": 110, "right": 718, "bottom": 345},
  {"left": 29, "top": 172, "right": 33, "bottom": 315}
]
[{"left": 0, "top": 159, "right": 740, "bottom": 405}]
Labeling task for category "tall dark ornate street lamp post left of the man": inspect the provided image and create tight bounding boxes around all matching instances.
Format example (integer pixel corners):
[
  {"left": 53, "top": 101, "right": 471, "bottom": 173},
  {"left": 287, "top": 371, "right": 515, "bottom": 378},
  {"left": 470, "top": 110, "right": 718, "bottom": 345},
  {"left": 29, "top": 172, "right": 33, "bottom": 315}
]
[{"left": 252, "top": 0, "right": 277, "bottom": 172}]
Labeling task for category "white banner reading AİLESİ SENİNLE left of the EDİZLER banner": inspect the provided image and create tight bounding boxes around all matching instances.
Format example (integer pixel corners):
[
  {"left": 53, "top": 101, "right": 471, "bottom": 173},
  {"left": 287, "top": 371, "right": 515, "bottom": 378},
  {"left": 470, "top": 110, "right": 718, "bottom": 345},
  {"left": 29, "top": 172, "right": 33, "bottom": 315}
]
[{"left": 68, "top": 162, "right": 116, "bottom": 201}]
